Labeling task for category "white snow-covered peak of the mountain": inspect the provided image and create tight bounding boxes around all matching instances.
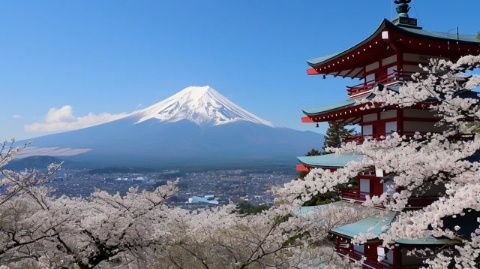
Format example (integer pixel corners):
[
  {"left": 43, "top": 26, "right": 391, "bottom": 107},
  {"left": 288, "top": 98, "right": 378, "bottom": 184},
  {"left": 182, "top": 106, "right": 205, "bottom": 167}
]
[{"left": 135, "top": 86, "right": 273, "bottom": 126}]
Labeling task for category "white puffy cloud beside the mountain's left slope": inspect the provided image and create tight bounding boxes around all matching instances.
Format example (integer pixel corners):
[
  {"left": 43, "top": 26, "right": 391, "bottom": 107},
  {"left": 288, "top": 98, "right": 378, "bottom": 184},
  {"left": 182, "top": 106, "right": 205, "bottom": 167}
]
[{"left": 24, "top": 105, "right": 128, "bottom": 133}]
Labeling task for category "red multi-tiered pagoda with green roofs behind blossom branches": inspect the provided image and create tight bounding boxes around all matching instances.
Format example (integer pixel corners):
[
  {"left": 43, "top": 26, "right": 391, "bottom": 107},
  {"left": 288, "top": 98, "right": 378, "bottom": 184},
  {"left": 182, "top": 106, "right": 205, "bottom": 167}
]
[{"left": 297, "top": 0, "right": 480, "bottom": 268}]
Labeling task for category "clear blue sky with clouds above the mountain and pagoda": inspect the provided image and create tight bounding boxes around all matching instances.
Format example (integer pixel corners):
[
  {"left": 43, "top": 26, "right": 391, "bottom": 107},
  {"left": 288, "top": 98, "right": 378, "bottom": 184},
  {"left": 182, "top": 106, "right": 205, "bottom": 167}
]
[{"left": 0, "top": 0, "right": 480, "bottom": 139}]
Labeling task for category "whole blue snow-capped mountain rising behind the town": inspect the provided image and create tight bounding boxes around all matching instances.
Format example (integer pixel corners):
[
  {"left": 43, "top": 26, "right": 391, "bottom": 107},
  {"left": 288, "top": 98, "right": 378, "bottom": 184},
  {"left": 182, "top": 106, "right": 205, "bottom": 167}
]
[{"left": 21, "top": 86, "right": 323, "bottom": 168}]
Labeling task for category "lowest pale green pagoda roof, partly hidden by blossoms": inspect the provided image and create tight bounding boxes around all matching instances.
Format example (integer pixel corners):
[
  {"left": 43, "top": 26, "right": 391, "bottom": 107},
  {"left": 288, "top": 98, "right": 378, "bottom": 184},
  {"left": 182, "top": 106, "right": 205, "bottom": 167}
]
[{"left": 331, "top": 211, "right": 458, "bottom": 245}]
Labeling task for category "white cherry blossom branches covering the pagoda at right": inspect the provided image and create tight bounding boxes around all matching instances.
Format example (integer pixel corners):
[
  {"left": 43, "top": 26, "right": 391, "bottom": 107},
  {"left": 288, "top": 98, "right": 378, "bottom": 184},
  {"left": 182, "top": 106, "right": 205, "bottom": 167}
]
[{"left": 277, "top": 53, "right": 480, "bottom": 268}]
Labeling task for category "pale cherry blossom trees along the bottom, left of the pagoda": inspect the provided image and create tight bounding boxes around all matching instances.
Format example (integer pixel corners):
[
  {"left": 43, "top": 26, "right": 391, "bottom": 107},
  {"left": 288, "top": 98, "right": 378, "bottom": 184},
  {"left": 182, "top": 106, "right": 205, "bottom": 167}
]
[{"left": 0, "top": 140, "right": 365, "bottom": 268}]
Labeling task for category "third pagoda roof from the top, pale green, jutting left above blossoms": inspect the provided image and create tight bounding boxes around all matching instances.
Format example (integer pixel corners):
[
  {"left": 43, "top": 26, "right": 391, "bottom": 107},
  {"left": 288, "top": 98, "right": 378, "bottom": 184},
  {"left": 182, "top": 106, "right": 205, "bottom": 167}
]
[{"left": 297, "top": 153, "right": 361, "bottom": 168}]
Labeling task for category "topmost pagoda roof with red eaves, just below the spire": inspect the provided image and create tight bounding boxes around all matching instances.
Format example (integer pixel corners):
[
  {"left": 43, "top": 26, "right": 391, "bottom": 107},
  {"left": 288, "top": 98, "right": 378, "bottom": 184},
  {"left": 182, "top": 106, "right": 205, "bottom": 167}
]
[{"left": 307, "top": 19, "right": 480, "bottom": 78}]
